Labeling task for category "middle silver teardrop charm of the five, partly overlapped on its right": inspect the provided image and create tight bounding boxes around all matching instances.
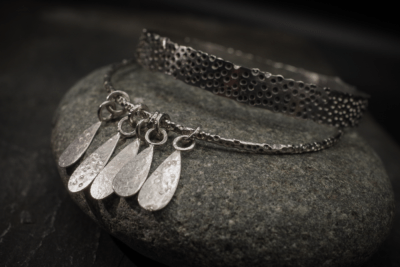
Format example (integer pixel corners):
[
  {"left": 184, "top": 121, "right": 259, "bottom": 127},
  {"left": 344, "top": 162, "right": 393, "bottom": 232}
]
[{"left": 90, "top": 138, "right": 140, "bottom": 199}]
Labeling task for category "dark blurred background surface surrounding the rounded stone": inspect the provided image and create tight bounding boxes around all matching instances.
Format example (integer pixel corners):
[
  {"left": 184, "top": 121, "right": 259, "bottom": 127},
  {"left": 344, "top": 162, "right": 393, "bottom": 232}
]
[{"left": 0, "top": 0, "right": 400, "bottom": 266}]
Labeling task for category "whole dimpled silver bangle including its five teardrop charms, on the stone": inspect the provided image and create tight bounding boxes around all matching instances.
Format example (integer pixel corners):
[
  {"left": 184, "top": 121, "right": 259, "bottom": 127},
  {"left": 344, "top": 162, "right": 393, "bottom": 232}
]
[{"left": 59, "top": 30, "right": 367, "bottom": 211}]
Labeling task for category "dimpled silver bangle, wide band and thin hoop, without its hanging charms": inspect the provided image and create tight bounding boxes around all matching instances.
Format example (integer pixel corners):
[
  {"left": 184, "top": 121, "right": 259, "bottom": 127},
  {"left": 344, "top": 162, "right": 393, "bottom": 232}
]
[{"left": 104, "top": 29, "right": 369, "bottom": 154}]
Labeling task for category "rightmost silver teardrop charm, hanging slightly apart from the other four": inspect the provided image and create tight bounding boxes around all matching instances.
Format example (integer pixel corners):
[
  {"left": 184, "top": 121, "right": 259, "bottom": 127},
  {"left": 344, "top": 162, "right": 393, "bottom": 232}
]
[{"left": 138, "top": 150, "right": 181, "bottom": 211}]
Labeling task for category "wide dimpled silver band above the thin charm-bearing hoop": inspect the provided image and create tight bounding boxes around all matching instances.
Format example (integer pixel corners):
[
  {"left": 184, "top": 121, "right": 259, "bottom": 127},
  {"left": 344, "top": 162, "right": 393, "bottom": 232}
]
[{"left": 137, "top": 30, "right": 368, "bottom": 128}]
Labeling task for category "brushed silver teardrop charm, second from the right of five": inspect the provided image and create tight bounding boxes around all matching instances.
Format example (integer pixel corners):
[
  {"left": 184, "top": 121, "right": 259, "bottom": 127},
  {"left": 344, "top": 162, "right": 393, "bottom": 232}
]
[{"left": 113, "top": 145, "right": 154, "bottom": 197}]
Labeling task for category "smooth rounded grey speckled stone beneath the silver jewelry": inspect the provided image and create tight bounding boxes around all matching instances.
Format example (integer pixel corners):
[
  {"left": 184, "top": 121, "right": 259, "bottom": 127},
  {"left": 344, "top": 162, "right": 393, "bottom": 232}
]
[{"left": 52, "top": 66, "right": 394, "bottom": 266}]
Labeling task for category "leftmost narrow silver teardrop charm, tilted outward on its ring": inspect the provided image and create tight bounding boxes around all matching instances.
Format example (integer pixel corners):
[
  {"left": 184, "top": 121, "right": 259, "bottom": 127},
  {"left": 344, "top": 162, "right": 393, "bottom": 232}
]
[{"left": 58, "top": 121, "right": 101, "bottom": 168}]
